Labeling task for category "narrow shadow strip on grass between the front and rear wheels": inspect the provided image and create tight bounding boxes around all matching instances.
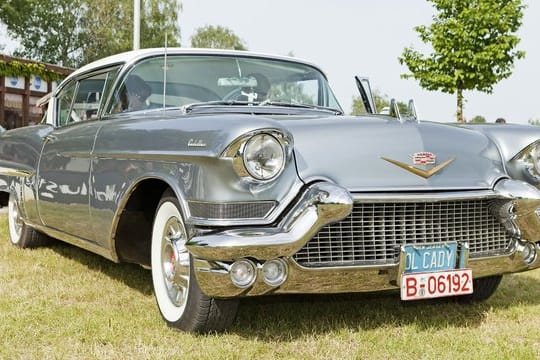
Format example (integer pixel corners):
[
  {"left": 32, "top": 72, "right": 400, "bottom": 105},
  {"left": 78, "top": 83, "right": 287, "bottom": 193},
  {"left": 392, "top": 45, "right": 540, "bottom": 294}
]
[{"left": 49, "top": 241, "right": 153, "bottom": 295}]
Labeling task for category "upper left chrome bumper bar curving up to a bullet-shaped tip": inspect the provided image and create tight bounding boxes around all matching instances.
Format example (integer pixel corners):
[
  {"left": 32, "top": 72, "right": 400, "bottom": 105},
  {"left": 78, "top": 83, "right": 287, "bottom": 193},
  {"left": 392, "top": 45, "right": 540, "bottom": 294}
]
[{"left": 186, "top": 182, "right": 353, "bottom": 261}]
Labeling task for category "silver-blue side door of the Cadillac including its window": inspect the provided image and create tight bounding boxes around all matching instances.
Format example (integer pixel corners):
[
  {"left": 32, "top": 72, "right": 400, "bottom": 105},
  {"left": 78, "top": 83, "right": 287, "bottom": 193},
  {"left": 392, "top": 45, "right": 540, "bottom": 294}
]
[{"left": 37, "top": 69, "right": 117, "bottom": 241}]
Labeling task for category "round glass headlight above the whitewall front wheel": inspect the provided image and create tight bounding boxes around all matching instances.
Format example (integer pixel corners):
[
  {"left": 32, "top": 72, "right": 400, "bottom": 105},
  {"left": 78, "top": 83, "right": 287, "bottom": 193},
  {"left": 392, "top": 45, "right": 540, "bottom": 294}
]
[{"left": 244, "top": 134, "right": 285, "bottom": 180}]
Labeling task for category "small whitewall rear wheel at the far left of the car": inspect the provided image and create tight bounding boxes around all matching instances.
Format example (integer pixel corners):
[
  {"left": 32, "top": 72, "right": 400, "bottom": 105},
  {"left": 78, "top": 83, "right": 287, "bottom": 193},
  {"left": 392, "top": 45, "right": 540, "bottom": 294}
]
[{"left": 8, "top": 194, "right": 50, "bottom": 249}]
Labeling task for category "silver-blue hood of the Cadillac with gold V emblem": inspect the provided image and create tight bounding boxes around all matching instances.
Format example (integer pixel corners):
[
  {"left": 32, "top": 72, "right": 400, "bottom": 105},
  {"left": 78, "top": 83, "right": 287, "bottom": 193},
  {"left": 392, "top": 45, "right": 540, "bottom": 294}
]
[{"left": 282, "top": 117, "right": 506, "bottom": 192}]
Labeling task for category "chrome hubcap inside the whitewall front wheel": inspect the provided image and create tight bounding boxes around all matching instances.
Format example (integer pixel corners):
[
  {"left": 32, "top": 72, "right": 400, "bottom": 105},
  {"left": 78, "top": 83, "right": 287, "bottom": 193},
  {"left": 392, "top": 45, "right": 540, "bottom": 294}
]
[{"left": 161, "top": 217, "right": 189, "bottom": 306}]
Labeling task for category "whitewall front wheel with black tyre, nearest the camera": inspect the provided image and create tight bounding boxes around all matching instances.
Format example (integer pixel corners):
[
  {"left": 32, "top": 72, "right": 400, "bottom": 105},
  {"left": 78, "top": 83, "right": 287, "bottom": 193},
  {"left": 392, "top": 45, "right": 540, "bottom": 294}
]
[{"left": 151, "top": 192, "right": 238, "bottom": 332}]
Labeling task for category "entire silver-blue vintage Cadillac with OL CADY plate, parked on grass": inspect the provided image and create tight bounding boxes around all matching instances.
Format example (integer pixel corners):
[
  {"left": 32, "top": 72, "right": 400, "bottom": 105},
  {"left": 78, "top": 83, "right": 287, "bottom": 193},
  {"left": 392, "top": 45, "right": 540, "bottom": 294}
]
[{"left": 0, "top": 49, "right": 540, "bottom": 332}]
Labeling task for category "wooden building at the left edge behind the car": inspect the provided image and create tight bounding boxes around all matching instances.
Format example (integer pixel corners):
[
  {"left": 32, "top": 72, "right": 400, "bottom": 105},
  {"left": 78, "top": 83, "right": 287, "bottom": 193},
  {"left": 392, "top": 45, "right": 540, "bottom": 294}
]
[{"left": 0, "top": 54, "right": 74, "bottom": 129}]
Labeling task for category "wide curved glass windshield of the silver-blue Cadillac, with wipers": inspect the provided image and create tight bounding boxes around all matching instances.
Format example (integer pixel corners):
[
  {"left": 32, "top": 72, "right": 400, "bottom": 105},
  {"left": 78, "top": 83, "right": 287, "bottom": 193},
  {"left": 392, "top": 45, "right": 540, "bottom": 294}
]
[{"left": 109, "top": 55, "right": 341, "bottom": 112}]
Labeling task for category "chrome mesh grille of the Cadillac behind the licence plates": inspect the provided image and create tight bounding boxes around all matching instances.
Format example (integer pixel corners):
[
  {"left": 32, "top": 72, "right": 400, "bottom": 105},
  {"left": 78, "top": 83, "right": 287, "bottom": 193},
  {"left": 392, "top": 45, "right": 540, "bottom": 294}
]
[{"left": 294, "top": 199, "right": 511, "bottom": 267}]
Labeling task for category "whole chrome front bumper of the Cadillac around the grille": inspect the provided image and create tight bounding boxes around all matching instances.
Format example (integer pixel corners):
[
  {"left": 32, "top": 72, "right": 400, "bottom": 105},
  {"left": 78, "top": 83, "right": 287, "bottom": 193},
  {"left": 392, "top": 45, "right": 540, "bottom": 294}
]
[{"left": 186, "top": 180, "right": 540, "bottom": 297}]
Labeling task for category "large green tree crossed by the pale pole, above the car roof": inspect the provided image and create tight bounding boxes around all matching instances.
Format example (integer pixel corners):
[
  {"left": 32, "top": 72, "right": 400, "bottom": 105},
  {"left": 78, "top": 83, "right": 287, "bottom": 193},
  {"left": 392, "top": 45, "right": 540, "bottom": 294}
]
[{"left": 0, "top": 0, "right": 182, "bottom": 67}]
